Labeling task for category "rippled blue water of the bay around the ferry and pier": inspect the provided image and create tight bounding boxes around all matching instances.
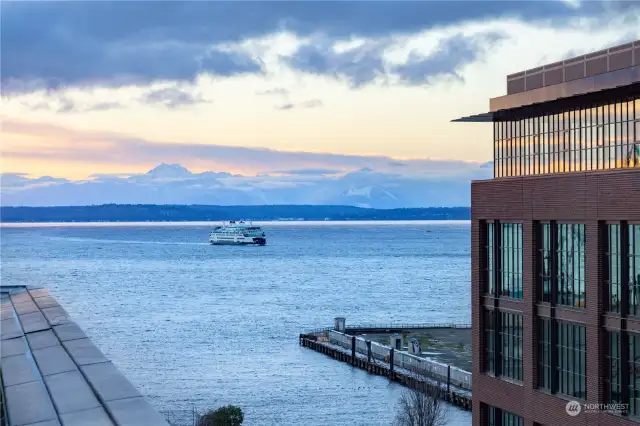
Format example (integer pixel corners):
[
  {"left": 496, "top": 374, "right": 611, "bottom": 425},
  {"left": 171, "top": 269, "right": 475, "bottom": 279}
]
[{"left": 0, "top": 222, "right": 471, "bottom": 425}]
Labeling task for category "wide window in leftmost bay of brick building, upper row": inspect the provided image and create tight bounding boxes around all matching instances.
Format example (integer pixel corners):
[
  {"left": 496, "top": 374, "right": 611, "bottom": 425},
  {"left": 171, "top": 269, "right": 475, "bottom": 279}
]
[{"left": 499, "top": 223, "right": 522, "bottom": 299}]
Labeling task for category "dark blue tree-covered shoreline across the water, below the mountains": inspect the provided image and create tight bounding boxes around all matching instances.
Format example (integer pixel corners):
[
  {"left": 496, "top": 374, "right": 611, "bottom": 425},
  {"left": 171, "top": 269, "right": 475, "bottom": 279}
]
[{"left": 0, "top": 204, "right": 471, "bottom": 222}]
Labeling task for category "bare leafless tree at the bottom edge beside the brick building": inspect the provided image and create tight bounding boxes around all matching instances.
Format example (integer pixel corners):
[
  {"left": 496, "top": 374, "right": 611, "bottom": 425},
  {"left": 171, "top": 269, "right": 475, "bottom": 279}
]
[{"left": 393, "top": 383, "right": 448, "bottom": 426}]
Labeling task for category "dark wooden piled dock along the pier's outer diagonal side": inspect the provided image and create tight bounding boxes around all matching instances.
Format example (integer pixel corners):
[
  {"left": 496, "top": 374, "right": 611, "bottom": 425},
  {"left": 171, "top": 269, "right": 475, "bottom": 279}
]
[{"left": 300, "top": 334, "right": 471, "bottom": 411}]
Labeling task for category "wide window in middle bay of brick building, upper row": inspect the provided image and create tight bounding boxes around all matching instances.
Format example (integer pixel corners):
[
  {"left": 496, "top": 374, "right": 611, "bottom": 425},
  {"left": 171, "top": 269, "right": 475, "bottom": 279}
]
[{"left": 557, "top": 223, "right": 585, "bottom": 308}]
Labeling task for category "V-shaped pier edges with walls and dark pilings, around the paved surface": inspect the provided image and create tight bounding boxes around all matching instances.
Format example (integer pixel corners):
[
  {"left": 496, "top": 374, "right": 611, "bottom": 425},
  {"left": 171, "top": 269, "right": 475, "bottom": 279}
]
[{"left": 299, "top": 318, "right": 472, "bottom": 411}]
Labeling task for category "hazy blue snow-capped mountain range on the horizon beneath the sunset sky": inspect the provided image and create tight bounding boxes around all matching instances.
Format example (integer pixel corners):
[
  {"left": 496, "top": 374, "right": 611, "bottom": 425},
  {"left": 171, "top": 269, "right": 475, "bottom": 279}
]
[{"left": 0, "top": 163, "right": 492, "bottom": 209}]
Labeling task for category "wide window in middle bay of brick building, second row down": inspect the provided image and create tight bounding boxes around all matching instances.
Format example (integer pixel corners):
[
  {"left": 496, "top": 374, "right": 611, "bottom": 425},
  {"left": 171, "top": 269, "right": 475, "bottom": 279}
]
[{"left": 557, "top": 322, "right": 586, "bottom": 399}]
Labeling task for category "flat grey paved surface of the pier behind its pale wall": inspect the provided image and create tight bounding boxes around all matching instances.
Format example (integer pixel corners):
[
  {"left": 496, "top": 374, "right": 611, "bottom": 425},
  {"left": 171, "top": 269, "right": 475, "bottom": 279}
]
[{"left": 360, "top": 328, "right": 472, "bottom": 371}]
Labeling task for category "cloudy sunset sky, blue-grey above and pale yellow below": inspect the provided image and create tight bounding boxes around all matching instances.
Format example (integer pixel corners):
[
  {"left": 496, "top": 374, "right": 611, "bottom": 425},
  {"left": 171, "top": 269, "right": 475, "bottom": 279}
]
[{"left": 0, "top": 0, "right": 640, "bottom": 181}]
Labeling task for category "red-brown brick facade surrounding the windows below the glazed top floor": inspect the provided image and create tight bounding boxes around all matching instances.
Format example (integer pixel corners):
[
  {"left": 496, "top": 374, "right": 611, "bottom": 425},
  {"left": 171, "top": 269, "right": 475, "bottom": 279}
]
[{"left": 471, "top": 168, "right": 640, "bottom": 426}]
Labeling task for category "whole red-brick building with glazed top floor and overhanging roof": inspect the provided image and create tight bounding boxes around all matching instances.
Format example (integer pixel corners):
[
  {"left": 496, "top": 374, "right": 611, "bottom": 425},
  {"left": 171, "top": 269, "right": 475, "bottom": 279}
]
[{"left": 454, "top": 41, "right": 640, "bottom": 426}]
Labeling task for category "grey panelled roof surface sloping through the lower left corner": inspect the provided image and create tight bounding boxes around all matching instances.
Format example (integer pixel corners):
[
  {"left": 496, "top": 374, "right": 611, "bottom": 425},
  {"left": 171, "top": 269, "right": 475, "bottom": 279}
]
[{"left": 0, "top": 286, "right": 168, "bottom": 426}]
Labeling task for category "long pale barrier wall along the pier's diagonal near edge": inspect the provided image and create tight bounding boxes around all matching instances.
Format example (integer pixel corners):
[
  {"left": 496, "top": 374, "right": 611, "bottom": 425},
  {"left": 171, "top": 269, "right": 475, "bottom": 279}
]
[{"left": 326, "top": 330, "right": 471, "bottom": 391}]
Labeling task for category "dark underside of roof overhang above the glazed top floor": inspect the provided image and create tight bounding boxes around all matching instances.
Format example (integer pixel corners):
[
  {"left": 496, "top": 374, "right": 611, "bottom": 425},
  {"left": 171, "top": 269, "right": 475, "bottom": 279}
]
[{"left": 451, "top": 82, "right": 640, "bottom": 123}]
